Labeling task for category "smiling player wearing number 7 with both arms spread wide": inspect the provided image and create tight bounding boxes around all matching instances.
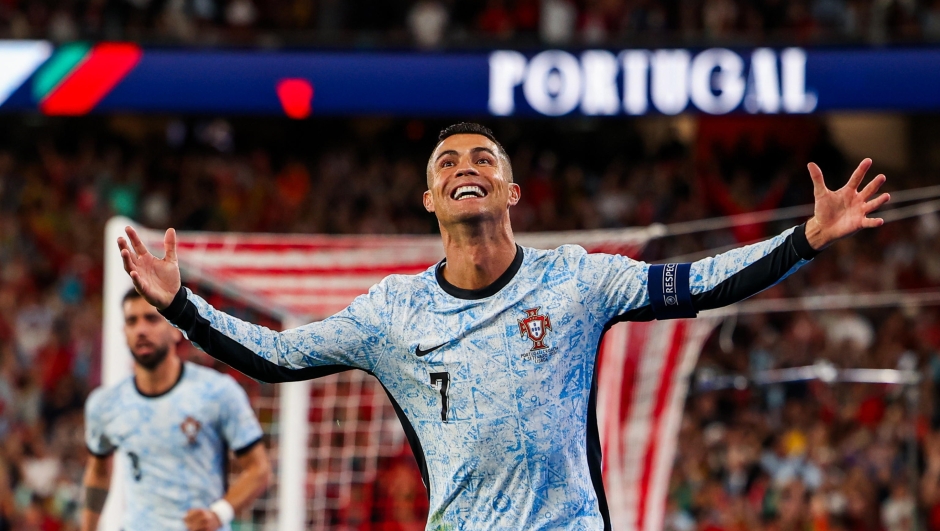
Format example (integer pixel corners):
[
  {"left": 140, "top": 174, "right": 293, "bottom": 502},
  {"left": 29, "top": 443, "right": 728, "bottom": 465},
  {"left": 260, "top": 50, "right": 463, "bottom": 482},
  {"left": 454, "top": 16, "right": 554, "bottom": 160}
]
[{"left": 118, "top": 124, "right": 888, "bottom": 531}]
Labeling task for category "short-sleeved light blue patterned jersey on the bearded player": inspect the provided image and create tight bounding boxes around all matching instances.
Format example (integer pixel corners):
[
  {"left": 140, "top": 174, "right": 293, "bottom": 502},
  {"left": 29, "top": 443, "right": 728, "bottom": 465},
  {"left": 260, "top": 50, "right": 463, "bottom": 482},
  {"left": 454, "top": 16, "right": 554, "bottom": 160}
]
[{"left": 85, "top": 362, "right": 262, "bottom": 531}]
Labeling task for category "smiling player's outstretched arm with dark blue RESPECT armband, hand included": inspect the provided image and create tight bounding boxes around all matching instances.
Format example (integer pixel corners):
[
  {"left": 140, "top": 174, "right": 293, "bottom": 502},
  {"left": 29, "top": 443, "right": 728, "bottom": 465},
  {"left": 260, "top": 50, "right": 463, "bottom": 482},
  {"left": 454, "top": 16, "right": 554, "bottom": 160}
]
[{"left": 588, "top": 159, "right": 889, "bottom": 321}]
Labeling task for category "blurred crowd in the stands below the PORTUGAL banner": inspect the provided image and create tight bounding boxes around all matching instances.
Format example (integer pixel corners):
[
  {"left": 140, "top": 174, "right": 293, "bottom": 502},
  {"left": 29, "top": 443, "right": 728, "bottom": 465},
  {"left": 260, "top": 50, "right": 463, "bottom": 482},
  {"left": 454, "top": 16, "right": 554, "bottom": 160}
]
[{"left": 0, "top": 111, "right": 940, "bottom": 531}]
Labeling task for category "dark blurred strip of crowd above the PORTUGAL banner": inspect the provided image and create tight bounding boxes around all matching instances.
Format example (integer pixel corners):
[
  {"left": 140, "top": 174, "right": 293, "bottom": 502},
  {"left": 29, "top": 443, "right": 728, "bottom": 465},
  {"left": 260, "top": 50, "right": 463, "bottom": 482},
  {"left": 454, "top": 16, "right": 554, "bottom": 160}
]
[{"left": 0, "top": 0, "right": 940, "bottom": 48}]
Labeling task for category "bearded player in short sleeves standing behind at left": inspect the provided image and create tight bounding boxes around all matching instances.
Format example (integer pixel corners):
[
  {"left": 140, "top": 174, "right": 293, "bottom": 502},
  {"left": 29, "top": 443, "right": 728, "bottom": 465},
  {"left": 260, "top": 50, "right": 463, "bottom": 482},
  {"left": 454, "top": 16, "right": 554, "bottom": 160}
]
[{"left": 81, "top": 289, "right": 271, "bottom": 531}]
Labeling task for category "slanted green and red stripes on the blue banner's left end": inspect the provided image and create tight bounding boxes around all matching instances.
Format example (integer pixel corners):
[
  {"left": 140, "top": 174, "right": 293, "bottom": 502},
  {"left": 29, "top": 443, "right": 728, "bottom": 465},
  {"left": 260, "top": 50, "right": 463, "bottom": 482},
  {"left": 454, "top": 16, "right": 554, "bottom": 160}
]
[{"left": 33, "top": 42, "right": 143, "bottom": 116}]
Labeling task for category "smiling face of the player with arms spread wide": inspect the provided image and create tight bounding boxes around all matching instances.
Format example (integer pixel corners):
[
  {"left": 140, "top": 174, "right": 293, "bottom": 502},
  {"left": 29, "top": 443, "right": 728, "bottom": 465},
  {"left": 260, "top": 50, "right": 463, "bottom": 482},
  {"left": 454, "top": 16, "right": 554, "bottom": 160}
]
[{"left": 424, "top": 134, "right": 519, "bottom": 225}]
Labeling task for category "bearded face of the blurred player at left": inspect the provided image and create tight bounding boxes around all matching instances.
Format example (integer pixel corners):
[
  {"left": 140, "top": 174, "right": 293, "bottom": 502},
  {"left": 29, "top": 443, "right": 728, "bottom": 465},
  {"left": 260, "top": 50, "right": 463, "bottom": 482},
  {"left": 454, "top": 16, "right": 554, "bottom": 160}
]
[{"left": 124, "top": 298, "right": 180, "bottom": 370}]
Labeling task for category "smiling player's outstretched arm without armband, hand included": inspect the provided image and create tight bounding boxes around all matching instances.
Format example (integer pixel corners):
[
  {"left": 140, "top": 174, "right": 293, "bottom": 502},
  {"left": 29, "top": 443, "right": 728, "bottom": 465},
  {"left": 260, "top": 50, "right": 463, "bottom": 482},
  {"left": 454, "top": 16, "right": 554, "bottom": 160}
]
[{"left": 118, "top": 227, "right": 384, "bottom": 383}]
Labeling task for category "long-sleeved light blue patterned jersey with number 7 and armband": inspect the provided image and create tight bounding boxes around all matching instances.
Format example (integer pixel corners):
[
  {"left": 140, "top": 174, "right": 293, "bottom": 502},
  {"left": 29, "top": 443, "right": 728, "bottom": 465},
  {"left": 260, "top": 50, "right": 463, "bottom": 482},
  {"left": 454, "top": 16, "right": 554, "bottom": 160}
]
[{"left": 163, "top": 222, "right": 815, "bottom": 531}]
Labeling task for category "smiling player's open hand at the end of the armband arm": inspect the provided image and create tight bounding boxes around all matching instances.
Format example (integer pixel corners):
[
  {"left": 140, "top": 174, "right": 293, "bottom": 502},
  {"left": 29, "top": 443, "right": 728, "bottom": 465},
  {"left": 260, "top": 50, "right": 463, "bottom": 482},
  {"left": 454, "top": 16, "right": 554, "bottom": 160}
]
[{"left": 806, "top": 159, "right": 891, "bottom": 250}]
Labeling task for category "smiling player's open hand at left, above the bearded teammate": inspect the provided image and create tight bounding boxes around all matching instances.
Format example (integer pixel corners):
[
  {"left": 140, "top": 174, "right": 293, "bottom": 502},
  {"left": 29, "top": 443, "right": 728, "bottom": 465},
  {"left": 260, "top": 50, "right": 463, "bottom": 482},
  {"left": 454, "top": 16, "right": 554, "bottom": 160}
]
[{"left": 118, "top": 227, "right": 181, "bottom": 310}]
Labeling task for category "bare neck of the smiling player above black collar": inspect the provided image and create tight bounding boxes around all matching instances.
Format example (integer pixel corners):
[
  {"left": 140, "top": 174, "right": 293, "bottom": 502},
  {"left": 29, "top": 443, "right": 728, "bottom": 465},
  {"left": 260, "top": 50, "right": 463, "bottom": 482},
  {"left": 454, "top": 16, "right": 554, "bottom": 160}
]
[{"left": 441, "top": 212, "right": 516, "bottom": 290}]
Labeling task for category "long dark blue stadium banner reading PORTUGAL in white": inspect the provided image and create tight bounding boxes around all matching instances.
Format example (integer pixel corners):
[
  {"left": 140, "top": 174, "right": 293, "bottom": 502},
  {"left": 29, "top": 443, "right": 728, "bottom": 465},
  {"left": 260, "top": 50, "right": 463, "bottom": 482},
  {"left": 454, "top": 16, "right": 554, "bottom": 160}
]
[{"left": 0, "top": 41, "right": 940, "bottom": 119}]
